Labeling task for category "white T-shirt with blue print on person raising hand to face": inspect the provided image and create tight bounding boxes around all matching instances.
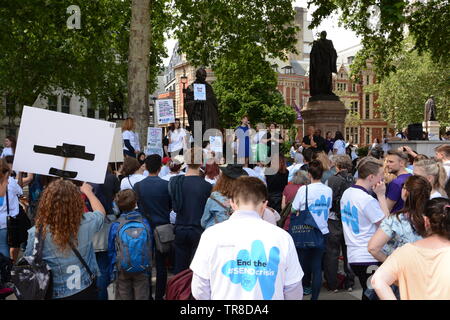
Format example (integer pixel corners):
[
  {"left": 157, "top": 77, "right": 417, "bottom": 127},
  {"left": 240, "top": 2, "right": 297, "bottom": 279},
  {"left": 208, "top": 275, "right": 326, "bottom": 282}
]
[{"left": 341, "top": 187, "right": 385, "bottom": 263}]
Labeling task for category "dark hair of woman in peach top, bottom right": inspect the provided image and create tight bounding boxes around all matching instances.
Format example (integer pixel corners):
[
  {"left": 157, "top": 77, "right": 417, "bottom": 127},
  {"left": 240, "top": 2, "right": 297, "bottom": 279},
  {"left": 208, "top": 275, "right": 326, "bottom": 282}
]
[{"left": 419, "top": 198, "right": 450, "bottom": 240}]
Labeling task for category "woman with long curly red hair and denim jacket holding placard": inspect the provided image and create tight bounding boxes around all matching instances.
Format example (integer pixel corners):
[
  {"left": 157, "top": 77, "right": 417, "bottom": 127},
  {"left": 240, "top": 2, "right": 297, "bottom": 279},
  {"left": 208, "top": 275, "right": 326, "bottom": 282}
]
[{"left": 25, "top": 179, "right": 105, "bottom": 300}]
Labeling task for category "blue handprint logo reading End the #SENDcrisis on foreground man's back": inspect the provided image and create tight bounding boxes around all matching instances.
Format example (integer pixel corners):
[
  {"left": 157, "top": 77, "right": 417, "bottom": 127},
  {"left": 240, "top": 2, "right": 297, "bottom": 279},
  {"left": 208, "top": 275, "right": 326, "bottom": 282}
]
[{"left": 222, "top": 240, "right": 280, "bottom": 300}]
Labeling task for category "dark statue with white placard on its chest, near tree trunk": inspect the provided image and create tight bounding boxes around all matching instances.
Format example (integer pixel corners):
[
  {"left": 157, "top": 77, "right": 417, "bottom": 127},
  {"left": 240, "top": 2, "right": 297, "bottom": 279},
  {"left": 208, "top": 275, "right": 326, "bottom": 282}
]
[{"left": 185, "top": 68, "right": 219, "bottom": 134}]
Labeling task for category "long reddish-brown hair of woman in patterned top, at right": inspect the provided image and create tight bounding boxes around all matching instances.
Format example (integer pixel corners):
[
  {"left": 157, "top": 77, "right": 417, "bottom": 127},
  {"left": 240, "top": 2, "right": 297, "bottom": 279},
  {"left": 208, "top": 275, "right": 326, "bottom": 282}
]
[{"left": 393, "top": 176, "right": 432, "bottom": 232}]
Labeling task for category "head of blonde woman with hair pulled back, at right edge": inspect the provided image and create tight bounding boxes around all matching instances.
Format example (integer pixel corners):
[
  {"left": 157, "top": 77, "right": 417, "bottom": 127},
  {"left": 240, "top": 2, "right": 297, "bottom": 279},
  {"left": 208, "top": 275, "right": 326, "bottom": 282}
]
[{"left": 413, "top": 159, "right": 447, "bottom": 199}]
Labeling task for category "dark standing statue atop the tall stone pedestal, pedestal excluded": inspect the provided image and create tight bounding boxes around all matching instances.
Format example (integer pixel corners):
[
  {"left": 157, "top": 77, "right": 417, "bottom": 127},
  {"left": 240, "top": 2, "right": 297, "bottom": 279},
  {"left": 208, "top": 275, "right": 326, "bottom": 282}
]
[{"left": 309, "top": 31, "right": 339, "bottom": 101}]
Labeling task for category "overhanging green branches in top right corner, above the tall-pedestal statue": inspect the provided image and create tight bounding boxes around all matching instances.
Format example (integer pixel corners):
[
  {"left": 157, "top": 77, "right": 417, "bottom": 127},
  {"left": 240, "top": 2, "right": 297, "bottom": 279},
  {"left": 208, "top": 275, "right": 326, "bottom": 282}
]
[{"left": 308, "top": 0, "right": 450, "bottom": 77}]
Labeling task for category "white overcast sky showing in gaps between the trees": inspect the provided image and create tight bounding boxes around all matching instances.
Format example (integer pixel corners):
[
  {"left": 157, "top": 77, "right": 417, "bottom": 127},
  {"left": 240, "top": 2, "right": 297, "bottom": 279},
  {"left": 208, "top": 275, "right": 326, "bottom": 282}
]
[{"left": 164, "top": 0, "right": 360, "bottom": 65}]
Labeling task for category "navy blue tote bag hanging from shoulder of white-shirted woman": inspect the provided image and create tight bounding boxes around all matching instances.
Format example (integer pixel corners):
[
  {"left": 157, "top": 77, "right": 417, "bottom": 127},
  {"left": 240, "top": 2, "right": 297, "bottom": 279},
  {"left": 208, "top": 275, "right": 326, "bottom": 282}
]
[{"left": 289, "top": 186, "right": 325, "bottom": 249}]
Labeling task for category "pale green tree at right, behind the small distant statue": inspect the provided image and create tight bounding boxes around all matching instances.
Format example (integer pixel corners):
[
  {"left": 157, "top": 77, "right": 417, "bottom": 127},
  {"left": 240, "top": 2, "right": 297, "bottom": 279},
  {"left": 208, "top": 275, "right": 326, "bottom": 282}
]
[{"left": 368, "top": 49, "right": 450, "bottom": 128}]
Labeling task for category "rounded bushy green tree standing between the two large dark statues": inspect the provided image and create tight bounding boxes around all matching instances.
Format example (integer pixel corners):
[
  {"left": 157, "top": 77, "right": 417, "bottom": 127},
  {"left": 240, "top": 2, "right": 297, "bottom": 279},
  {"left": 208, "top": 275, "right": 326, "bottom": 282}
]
[{"left": 213, "top": 45, "right": 296, "bottom": 128}]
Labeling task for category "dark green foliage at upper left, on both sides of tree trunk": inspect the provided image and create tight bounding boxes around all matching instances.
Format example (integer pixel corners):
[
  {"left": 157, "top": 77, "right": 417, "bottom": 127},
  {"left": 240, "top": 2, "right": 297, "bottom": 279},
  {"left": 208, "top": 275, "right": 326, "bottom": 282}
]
[{"left": 0, "top": 0, "right": 170, "bottom": 119}]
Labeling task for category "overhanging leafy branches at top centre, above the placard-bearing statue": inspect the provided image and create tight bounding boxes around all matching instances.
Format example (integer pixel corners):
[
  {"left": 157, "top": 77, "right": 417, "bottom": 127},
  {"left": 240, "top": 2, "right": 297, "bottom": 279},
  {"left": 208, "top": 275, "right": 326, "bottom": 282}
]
[{"left": 174, "top": 0, "right": 297, "bottom": 66}]
